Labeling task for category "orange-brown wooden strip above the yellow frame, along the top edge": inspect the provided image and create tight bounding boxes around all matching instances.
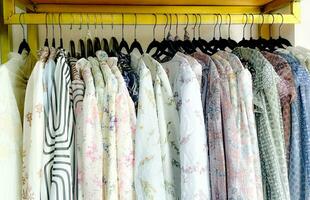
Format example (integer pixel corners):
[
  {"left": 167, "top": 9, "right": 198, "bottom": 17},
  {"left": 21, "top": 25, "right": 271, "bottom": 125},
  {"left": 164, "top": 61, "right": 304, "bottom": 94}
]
[{"left": 32, "top": 0, "right": 272, "bottom": 6}]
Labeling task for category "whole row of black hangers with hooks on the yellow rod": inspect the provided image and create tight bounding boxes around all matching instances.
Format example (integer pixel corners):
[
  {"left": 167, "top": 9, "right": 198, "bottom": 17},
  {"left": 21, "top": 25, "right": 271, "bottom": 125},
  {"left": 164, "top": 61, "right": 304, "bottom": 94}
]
[{"left": 18, "top": 13, "right": 292, "bottom": 60}]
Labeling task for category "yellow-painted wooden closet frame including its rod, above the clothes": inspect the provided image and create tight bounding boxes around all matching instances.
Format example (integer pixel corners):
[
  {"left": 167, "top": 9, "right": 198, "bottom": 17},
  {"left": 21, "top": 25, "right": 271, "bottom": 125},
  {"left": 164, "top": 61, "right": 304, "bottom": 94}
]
[{"left": 0, "top": 0, "right": 300, "bottom": 63}]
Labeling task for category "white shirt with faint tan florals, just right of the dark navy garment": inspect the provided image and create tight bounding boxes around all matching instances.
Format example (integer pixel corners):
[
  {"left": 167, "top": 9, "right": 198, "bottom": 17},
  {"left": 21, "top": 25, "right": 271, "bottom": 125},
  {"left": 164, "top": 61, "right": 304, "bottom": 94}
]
[{"left": 131, "top": 54, "right": 166, "bottom": 200}]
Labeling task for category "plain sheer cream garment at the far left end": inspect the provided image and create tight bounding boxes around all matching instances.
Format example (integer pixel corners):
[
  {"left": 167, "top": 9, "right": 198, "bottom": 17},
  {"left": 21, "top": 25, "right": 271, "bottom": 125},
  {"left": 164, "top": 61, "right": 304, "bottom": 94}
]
[{"left": 0, "top": 53, "right": 25, "bottom": 200}]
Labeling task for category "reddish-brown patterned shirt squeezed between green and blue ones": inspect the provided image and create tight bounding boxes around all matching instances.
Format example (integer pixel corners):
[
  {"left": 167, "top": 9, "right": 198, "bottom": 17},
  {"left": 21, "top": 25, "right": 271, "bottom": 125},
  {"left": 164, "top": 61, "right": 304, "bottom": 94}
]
[{"left": 262, "top": 51, "right": 296, "bottom": 160}]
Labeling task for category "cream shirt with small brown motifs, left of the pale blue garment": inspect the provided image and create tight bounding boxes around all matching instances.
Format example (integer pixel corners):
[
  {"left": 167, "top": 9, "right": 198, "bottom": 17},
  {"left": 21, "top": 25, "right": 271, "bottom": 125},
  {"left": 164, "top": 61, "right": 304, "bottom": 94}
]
[{"left": 22, "top": 47, "right": 49, "bottom": 200}]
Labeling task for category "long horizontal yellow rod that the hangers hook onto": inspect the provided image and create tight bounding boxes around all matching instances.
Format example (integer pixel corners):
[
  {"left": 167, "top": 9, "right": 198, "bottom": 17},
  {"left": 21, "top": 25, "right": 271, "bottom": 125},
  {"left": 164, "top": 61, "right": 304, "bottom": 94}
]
[{"left": 7, "top": 13, "right": 298, "bottom": 25}]
